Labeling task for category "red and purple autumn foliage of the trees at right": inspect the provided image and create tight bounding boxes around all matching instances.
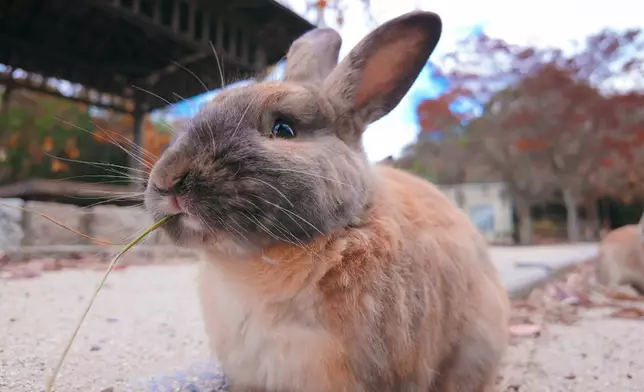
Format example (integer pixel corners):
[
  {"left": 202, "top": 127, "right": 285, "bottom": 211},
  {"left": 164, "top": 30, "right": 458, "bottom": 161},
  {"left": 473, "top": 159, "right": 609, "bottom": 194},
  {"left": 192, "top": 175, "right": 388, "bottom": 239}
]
[{"left": 417, "top": 25, "right": 644, "bottom": 202}]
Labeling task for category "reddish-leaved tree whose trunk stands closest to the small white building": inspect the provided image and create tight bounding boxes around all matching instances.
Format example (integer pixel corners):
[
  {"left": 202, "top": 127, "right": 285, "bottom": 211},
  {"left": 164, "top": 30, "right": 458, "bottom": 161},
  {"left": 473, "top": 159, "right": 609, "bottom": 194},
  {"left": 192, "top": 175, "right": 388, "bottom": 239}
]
[{"left": 419, "top": 84, "right": 553, "bottom": 244}]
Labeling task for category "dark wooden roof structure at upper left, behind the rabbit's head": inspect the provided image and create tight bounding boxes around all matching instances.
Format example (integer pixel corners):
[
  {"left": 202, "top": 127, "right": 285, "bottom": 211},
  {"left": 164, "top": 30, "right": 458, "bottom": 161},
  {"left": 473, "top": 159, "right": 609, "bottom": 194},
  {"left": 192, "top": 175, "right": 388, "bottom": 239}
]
[{"left": 0, "top": 0, "right": 313, "bottom": 113}]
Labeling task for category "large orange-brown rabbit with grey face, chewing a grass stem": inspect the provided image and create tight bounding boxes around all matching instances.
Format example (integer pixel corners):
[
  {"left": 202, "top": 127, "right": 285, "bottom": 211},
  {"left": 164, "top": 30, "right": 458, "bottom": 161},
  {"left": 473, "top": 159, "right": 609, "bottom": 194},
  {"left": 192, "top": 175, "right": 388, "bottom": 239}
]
[{"left": 146, "top": 12, "right": 509, "bottom": 392}]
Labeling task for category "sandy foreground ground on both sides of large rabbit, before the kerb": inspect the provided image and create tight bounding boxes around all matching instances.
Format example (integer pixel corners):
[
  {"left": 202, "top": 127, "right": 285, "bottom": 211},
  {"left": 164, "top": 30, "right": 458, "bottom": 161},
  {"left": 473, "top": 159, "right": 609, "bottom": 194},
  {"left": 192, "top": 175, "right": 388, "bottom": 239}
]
[{"left": 0, "top": 263, "right": 644, "bottom": 392}]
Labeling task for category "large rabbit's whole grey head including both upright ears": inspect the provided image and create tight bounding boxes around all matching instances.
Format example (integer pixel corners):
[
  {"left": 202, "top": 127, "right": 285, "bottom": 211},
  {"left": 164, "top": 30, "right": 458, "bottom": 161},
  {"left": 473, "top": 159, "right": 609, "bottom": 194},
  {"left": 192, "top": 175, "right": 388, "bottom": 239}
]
[{"left": 145, "top": 12, "right": 441, "bottom": 254}]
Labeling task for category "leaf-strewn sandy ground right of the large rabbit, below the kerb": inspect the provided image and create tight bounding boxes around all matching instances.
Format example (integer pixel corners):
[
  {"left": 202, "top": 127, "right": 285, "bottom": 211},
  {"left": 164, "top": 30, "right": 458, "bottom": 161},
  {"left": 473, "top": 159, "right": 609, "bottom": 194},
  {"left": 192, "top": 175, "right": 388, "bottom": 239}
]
[{"left": 500, "top": 263, "right": 644, "bottom": 392}]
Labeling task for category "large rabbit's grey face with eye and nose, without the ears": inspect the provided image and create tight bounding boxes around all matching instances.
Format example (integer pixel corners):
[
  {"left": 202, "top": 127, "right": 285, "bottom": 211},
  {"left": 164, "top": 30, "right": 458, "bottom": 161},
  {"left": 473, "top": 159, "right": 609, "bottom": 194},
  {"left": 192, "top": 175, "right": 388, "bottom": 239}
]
[{"left": 145, "top": 82, "right": 368, "bottom": 251}]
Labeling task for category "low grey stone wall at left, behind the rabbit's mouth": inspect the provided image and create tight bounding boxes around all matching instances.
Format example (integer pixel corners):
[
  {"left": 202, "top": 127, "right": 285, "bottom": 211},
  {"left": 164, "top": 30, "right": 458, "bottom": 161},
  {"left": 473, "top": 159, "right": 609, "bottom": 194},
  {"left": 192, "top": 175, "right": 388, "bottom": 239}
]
[{"left": 0, "top": 199, "right": 169, "bottom": 249}]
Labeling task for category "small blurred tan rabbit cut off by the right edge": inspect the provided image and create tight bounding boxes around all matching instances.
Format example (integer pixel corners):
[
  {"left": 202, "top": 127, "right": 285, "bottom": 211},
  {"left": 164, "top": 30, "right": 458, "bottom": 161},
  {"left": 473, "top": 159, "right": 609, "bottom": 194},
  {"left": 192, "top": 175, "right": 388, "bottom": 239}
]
[{"left": 597, "top": 215, "right": 644, "bottom": 296}]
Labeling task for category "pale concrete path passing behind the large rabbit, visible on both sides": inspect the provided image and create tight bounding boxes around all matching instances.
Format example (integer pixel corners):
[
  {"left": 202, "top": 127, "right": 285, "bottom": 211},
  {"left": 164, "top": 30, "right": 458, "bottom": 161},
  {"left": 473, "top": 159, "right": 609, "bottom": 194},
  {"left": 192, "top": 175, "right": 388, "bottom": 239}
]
[{"left": 0, "top": 245, "right": 596, "bottom": 392}]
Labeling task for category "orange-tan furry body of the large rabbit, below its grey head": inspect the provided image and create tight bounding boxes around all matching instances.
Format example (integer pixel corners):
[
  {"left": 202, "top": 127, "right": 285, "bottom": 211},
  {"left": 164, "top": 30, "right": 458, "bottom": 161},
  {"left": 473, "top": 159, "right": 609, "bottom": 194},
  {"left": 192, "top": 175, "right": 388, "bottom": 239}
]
[{"left": 200, "top": 167, "right": 508, "bottom": 392}]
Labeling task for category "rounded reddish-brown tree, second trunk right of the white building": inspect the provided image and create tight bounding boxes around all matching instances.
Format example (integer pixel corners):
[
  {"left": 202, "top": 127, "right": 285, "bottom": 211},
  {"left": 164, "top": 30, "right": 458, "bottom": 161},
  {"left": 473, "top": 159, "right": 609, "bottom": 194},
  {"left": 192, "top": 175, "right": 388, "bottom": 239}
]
[{"left": 504, "top": 62, "right": 614, "bottom": 242}]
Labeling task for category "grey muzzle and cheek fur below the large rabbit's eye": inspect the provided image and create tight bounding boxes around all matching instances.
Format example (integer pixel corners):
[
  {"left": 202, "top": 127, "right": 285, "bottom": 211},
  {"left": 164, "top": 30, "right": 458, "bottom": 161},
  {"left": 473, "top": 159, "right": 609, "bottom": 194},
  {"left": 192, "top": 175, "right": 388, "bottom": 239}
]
[{"left": 146, "top": 116, "right": 373, "bottom": 253}]
